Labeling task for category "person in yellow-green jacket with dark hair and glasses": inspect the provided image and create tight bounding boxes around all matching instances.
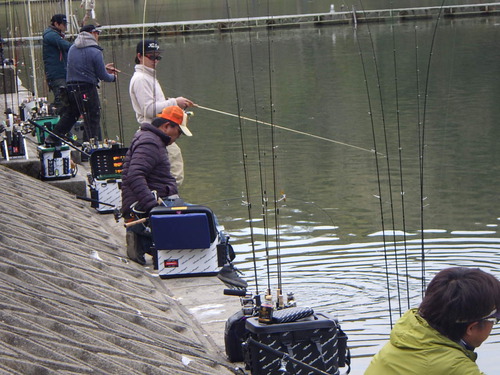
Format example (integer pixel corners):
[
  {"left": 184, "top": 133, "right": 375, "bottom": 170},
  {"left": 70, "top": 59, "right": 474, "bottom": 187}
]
[{"left": 365, "top": 267, "right": 500, "bottom": 375}]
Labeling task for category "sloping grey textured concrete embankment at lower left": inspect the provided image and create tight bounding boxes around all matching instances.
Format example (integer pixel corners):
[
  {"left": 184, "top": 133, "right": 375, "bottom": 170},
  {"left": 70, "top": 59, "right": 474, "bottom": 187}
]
[{"left": 0, "top": 165, "right": 236, "bottom": 375}]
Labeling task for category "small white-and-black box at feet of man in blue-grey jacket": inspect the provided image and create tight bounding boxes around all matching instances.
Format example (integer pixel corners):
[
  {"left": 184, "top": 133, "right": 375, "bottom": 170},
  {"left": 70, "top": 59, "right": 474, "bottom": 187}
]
[{"left": 38, "top": 145, "right": 73, "bottom": 180}]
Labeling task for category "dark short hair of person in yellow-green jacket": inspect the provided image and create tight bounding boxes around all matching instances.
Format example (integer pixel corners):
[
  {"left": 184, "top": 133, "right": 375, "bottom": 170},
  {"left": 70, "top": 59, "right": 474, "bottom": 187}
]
[{"left": 418, "top": 267, "right": 500, "bottom": 341}]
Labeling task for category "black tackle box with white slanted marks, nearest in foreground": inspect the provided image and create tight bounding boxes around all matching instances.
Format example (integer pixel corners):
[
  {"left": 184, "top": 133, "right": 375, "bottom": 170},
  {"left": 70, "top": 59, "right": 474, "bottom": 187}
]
[{"left": 244, "top": 314, "right": 347, "bottom": 375}]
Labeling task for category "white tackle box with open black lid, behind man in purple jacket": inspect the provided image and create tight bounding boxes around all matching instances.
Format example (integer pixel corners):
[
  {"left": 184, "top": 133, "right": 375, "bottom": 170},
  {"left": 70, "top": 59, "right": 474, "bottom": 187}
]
[{"left": 89, "top": 146, "right": 127, "bottom": 214}]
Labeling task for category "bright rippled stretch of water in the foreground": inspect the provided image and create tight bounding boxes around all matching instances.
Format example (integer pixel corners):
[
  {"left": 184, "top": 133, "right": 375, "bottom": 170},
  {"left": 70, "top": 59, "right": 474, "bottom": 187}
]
[{"left": 222, "top": 204, "right": 500, "bottom": 374}]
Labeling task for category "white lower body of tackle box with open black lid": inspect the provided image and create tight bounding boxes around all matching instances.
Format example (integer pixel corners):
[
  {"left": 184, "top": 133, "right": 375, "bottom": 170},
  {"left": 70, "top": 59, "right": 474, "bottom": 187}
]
[{"left": 90, "top": 178, "right": 122, "bottom": 214}]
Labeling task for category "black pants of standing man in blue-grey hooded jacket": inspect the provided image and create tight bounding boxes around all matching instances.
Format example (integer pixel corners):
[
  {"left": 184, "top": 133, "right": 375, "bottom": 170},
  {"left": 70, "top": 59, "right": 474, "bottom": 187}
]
[{"left": 54, "top": 83, "right": 102, "bottom": 141}]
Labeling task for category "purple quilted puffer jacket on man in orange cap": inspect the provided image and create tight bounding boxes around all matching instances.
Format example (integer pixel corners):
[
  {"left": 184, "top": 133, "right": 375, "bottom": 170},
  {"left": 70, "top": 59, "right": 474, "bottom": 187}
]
[{"left": 122, "top": 123, "right": 177, "bottom": 218}]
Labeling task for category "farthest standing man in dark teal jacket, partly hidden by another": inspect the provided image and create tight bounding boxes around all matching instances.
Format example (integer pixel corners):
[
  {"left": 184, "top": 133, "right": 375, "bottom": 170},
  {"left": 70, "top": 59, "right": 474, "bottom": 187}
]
[{"left": 43, "top": 14, "right": 71, "bottom": 113}]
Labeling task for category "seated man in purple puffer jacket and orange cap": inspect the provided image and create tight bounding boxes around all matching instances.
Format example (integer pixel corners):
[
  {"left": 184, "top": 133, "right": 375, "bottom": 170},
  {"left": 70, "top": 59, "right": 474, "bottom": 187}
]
[{"left": 122, "top": 106, "right": 192, "bottom": 265}]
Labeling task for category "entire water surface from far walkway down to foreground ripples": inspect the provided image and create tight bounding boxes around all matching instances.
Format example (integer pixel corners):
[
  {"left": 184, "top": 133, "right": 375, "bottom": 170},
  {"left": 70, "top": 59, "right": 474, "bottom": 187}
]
[{"left": 3, "top": 1, "right": 500, "bottom": 374}]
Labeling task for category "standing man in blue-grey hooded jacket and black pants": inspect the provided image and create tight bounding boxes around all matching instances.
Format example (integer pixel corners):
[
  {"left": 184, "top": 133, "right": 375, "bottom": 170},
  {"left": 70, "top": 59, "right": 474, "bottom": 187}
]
[{"left": 45, "top": 25, "right": 119, "bottom": 145}]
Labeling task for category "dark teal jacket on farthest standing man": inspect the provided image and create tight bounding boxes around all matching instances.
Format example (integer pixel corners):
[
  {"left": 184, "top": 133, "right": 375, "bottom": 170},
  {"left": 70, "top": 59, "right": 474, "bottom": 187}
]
[{"left": 43, "top": 26, "right": 71, "bottom": 82}]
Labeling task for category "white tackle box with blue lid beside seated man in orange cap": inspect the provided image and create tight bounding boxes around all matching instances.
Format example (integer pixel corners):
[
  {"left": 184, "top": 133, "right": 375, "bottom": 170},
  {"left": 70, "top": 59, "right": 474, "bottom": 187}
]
[{"left": 149, "top": 205, "right": 222, "bottom": 279}]
